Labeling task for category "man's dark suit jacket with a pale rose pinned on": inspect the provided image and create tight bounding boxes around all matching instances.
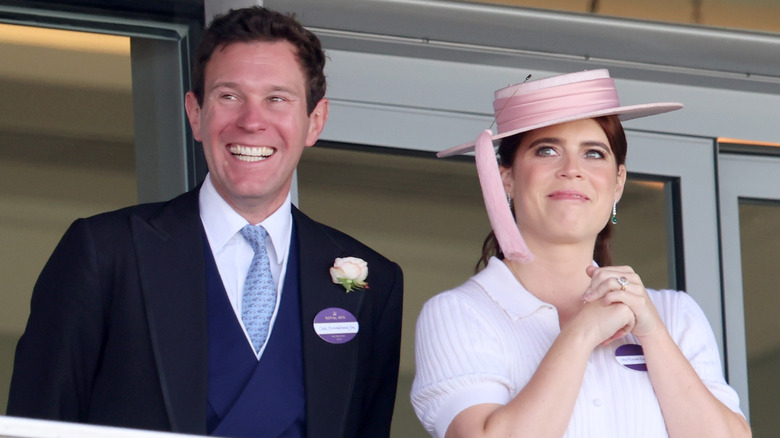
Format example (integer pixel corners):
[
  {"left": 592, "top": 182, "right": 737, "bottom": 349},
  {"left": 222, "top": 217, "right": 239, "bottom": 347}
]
[{"left": 7, "top": 189, "right": 403, "bottom": 437}]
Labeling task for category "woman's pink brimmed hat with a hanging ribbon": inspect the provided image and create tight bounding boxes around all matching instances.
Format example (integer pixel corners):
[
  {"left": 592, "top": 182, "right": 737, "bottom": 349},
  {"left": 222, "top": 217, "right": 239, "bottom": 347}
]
[{"left": 436, "top": 69, "right": 682, "bottom": 262}]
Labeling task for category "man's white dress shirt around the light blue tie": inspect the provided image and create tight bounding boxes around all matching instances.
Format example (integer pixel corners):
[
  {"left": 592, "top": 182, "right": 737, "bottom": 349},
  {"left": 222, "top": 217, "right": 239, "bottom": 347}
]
[{"left": 199, "top": 175, "right": 292, "bottom": 358}]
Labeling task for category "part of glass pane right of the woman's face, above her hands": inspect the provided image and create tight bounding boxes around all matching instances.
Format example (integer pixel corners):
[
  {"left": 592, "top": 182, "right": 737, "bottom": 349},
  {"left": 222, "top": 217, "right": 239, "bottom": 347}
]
[{"left": 612, "top": 175, "right": 676, "bottom": 289}]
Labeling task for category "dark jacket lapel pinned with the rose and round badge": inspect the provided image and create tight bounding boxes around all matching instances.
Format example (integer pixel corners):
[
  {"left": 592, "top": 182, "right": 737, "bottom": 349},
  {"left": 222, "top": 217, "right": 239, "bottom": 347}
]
[{"left": 293, "top": 208, "right": 365, "bottom": 436}]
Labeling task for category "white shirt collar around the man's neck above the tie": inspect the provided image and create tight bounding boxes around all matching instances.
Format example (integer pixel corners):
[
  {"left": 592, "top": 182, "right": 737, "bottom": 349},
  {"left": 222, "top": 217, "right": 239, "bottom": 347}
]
[{"left": 199, "top": 174, "right": 292, "bottom": 260}]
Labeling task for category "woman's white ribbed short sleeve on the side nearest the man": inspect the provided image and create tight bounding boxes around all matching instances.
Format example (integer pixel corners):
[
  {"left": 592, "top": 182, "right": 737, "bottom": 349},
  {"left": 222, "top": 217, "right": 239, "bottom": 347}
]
[{"left": 411, "top": 288, "right": 511, "bottom": 437}]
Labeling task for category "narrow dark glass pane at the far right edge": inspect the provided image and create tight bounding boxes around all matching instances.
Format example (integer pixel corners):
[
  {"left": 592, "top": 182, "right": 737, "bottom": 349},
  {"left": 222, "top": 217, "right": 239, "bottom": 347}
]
[{"left": 739, "top": 199, "right": 780, "bottom": 436}]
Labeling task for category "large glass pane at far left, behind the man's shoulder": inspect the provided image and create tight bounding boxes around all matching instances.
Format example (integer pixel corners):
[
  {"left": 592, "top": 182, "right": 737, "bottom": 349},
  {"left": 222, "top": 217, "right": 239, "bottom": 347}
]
[{"left": 0, "top": 25, "right": 136, "bottom": 413}]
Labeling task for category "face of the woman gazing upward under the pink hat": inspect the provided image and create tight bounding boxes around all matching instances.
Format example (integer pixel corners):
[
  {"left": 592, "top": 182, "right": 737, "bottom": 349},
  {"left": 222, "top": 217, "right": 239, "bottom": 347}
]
[{"left": 501, "top": 119, "right": 626, "bottom": 248}]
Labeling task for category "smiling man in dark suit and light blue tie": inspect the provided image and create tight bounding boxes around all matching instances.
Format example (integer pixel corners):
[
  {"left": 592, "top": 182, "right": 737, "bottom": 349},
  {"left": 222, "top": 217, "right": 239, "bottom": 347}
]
[{"left": 7, "top": 7, "right": 402, "bottom": 437}]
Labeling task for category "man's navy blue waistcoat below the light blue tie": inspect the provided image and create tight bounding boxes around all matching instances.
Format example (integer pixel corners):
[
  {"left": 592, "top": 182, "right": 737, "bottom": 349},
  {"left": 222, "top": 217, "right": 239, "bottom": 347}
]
[{"left": 203, "top": 226, "right": 306, "bottom": 438}]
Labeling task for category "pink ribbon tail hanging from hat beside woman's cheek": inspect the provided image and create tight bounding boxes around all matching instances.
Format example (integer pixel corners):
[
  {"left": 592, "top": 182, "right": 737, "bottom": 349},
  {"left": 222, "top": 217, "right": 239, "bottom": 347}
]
[{"left": 475, "top": 129, "right": 534, "bottom": 262}]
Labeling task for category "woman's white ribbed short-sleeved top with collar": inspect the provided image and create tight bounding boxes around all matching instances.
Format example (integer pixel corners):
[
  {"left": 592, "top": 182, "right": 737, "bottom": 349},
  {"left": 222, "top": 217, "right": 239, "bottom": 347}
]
[{"left": 411, "top": 258, "right": 741, "bottom": 438}]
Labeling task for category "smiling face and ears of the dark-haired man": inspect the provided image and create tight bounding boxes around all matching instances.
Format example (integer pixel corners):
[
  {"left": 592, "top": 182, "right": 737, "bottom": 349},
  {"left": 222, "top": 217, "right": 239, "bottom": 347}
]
[{"left": 186, "top": 41, "right": 328, "bottom": 222}]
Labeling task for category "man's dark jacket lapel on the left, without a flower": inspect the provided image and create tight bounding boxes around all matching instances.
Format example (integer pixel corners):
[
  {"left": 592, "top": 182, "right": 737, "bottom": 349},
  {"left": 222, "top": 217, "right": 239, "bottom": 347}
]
[{"left": 131, "top": 188, "right": 208, "bottom": 433}]
